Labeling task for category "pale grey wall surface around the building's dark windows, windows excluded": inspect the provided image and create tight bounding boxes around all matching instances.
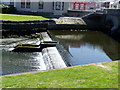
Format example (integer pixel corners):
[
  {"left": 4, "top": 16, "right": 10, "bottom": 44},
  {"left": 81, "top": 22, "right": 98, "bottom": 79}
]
[{"left": 16, "top": 2, "right": 71, "bottom": 13}]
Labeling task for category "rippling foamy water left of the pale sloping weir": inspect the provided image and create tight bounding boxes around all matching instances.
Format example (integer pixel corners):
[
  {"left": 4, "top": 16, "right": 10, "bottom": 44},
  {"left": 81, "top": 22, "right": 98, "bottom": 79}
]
[{"left": 0, "top": 38, "right": 46, "bottom": 75}]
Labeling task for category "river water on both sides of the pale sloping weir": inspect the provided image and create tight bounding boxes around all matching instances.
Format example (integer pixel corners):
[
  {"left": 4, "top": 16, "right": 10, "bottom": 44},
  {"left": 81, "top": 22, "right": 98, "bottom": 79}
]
[{"left": 0, "top": 30, "right": 120, "bottom": 75}]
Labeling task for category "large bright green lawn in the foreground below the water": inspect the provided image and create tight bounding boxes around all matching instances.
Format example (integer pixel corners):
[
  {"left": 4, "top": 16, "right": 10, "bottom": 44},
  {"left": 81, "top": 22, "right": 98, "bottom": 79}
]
[{"left": 2, "top": 61, "right": 118, "bottom": 88}]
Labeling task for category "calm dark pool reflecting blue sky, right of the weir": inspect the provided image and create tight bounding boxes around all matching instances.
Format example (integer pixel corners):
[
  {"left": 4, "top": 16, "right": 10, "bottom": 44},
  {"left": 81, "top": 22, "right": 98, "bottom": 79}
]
[{"left": 50, "top": 30, "right": 120, "bottom": 66}]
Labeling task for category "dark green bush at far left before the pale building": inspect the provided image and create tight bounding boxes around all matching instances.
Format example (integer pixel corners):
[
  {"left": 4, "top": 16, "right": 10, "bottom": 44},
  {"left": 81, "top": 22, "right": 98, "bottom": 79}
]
[{"left": 0, "top": 4, "right": 17, "bottom": 14}]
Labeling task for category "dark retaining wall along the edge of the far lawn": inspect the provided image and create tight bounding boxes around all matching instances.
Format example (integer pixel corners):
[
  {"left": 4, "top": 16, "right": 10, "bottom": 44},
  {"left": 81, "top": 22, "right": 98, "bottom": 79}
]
[{"left": 0, "top": 20, "right": 55, "bottom": 31}]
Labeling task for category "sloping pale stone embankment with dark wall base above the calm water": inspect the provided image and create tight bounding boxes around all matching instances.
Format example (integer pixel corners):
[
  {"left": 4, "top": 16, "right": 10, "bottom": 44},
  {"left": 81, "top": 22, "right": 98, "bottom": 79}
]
[{"left": 47, "top": 17, "right": 105, "bottom": 30}]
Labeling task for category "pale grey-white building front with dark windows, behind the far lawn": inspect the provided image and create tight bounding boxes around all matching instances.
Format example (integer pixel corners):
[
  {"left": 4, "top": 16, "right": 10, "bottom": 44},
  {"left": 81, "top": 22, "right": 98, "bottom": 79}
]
[{"left": 16, "top": 0, "right": 70, "bottom": 15}]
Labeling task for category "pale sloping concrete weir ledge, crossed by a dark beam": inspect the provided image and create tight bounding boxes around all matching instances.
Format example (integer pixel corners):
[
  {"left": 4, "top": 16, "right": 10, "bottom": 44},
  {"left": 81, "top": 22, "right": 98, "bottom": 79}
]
[{"left": 41, "top": 32, "right": 67, "bottom": 70}]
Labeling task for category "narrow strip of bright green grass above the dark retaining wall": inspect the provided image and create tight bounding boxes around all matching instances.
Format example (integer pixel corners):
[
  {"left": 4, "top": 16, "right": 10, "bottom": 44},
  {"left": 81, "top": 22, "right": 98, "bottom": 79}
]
[{"left": 0, "top": 14, "right": 49, "bottom": 21}]
